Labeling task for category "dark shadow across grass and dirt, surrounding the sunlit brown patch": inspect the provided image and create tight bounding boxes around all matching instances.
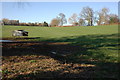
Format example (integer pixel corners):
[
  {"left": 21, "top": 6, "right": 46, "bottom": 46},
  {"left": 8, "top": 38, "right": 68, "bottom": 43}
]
[{"left": 3, "top": 34, "right": 119, "bottom": 80}]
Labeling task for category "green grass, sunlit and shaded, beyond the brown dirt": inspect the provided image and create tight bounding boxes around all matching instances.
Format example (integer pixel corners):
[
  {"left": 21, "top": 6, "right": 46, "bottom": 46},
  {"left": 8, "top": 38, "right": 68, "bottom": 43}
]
[{"left": 2, "top": 25, "right": 118, "bottom": 62}]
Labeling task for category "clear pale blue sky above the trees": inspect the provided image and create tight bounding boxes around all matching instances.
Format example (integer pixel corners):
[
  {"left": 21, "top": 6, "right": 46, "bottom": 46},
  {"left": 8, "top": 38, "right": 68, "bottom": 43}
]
[{"left": 2, "top": 2, "right": 118, "bottom": 24}]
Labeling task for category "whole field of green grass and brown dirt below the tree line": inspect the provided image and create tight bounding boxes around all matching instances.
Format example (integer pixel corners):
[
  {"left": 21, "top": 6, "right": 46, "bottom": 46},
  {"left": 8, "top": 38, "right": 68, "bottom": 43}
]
[{"left": 2, "top": 25, "right": 119, "bottom": 80}]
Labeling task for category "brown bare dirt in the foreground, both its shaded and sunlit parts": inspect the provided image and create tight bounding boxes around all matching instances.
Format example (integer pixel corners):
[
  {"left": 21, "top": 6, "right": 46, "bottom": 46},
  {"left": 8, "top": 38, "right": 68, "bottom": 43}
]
[{"left": 1, "top": 42, "right": 118, "bottom": 80}]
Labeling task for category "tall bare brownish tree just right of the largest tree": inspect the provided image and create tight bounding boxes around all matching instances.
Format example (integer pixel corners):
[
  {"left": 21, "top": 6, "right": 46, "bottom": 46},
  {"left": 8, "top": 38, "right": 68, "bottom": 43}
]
[{"left": 97, "top": 8, "right": 109, "bottom": 25}]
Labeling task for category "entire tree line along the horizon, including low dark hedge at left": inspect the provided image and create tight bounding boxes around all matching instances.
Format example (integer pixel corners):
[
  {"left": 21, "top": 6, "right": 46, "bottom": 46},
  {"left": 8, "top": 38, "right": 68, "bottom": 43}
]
[{"left": 2, "top": 6, "right": 119, "bottom": 27}]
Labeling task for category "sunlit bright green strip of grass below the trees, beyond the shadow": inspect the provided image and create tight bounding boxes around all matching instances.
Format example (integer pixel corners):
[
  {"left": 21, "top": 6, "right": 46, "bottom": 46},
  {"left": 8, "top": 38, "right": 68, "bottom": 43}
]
[{"left": 2, "top": 25, "right": 118, "bottom": 38}]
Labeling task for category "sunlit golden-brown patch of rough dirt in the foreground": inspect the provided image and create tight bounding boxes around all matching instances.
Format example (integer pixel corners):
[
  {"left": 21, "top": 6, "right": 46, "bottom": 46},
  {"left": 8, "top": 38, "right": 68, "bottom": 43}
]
[{"left": 2, "top": 55, "right": 95, "bottom": 79}]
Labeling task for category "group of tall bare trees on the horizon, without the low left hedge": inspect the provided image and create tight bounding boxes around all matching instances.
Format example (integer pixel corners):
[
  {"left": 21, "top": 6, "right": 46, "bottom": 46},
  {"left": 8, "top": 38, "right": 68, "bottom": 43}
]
[{"left": 51, "top": 6, "right": 119, "bottom": 26}]
